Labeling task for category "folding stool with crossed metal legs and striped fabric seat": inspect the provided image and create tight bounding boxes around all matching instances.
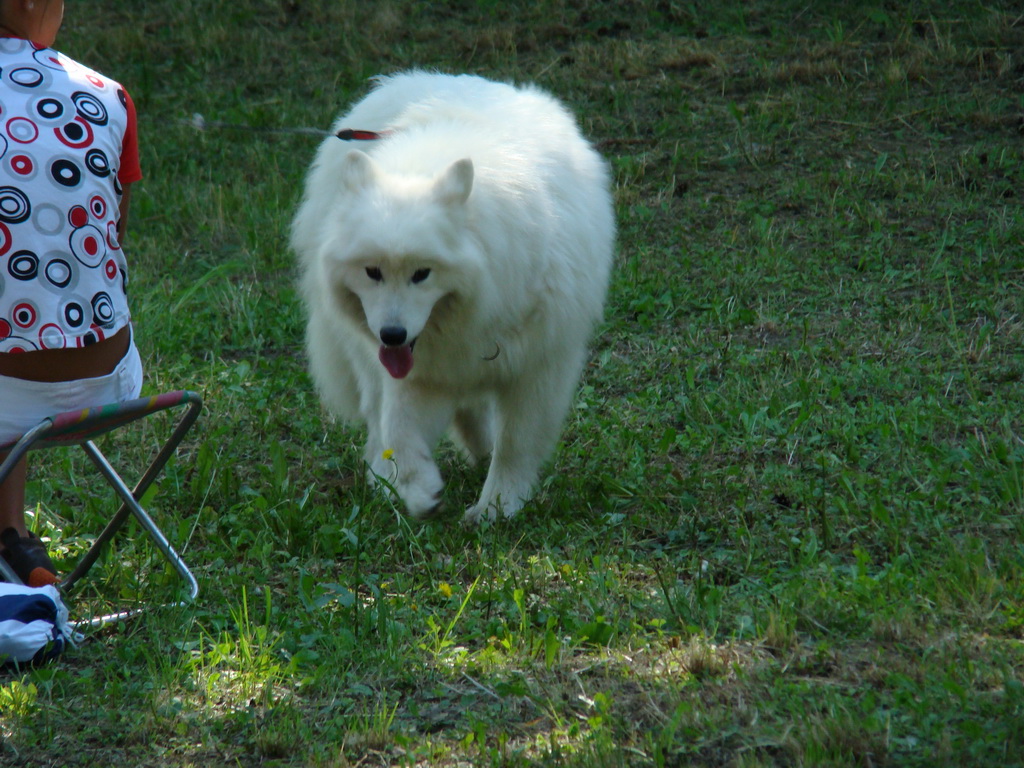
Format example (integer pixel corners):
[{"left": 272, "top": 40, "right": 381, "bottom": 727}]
[{"left": 0, "top": 390, "right": 203, "bottom": 600}]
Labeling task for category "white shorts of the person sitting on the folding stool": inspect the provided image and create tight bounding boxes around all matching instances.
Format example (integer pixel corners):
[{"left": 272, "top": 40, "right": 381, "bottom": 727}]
[{"left": 0, "top": 335, "right": 142, "bottom": 445}]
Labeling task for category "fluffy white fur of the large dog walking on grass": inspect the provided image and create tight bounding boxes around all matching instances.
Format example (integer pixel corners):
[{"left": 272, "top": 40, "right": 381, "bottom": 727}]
[{"left": 291, "top": 72, "right": 614, "bottom": 520}]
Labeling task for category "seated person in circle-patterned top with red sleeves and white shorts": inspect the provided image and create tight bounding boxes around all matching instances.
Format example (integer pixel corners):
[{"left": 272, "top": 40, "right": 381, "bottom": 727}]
[{"left": 0, "top": 0, "right": 142, "bottom": 587}]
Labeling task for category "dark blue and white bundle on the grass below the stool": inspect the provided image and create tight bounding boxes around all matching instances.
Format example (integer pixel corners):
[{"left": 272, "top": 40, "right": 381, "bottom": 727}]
[{"left": 0, "top": 582, "right": 74, "bottom": 665}]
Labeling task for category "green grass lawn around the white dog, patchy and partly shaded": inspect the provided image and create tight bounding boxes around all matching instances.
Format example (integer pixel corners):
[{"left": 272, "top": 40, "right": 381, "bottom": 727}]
[{"left": 0, "top": 0, "right": 1024, "bottom": 768}]
